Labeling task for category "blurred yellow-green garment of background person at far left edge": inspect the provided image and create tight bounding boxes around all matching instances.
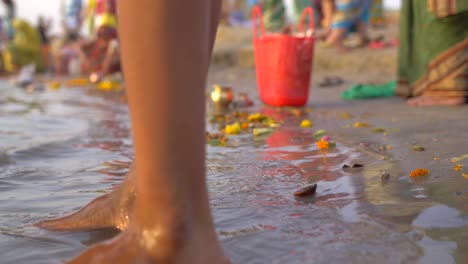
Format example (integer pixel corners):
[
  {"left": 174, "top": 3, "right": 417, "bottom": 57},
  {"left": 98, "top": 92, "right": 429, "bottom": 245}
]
[{"left": 3, "top": 19, "right": 43, "bottom": 72}]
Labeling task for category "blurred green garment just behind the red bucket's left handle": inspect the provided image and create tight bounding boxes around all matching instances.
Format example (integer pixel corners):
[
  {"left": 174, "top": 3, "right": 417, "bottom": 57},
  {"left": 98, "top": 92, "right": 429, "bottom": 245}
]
[{"left": 263, "top": 0, "right": 286, "bottom": 31}]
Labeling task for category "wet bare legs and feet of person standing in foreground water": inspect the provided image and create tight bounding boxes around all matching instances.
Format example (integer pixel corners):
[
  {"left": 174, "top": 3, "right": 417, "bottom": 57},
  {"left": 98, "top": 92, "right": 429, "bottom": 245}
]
[{"left": 38, "top": 0, "right": 226, "bottom": 263}]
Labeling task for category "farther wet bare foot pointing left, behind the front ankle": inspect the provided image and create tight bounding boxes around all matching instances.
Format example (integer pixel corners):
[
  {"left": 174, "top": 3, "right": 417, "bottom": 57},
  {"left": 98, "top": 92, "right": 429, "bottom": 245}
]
[{"left": 35, "top": 166, "right": 136, "bottom": 231}]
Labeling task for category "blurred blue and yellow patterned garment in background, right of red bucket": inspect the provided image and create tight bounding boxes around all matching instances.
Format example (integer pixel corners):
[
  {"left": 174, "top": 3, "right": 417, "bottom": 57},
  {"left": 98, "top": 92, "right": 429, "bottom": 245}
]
[{"left": 331, "top": 0, "right": 371, "bottom": 30}]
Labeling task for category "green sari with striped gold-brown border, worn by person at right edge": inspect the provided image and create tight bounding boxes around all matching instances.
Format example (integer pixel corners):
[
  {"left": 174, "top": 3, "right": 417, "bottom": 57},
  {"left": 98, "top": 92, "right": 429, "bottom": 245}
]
[{"left": 397, "top": 0, "right": 468, "bottom": 97}]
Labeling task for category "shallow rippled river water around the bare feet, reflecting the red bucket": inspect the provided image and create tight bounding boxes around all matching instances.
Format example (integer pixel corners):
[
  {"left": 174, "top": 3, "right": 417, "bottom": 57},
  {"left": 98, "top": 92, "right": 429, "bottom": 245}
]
[{"left": 0, "top": 83, "right": 468, "bottom": 263}]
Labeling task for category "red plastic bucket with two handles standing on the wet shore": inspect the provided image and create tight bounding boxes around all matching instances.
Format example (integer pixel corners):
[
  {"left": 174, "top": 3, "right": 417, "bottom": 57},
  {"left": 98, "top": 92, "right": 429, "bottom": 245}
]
[{"left": 252, "top": 6, "right": 315, "bottom": 106}]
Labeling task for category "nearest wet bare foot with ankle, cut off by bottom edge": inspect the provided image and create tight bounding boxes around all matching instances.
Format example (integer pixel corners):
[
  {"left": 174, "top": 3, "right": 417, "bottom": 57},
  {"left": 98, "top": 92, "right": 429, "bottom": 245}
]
[{"left": 69, "top": 227, "right": 230, "bottom": 264}]
